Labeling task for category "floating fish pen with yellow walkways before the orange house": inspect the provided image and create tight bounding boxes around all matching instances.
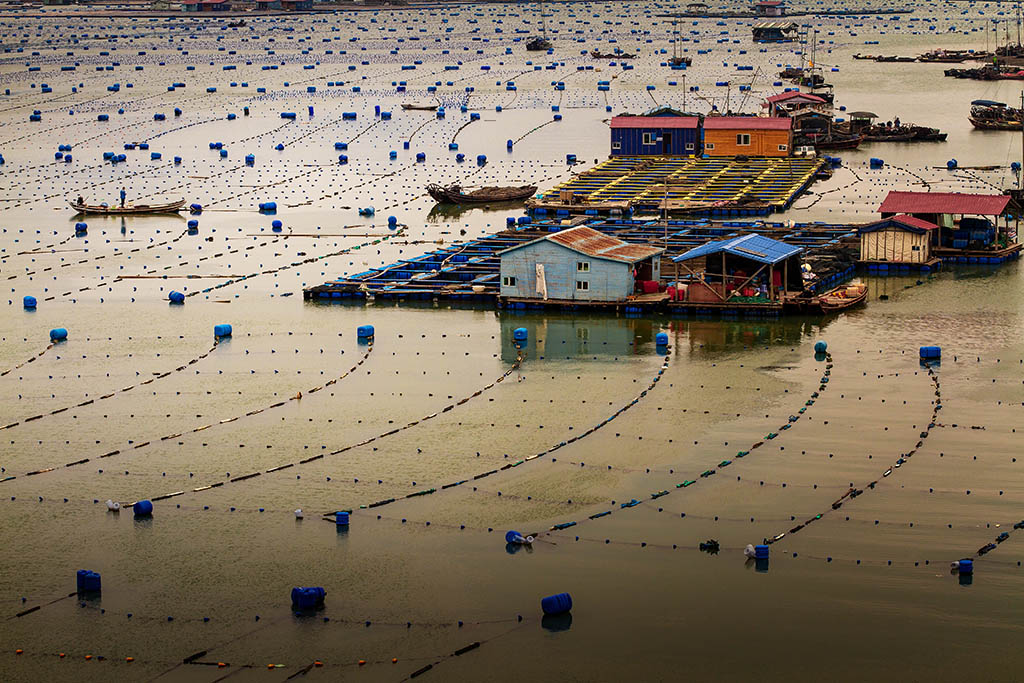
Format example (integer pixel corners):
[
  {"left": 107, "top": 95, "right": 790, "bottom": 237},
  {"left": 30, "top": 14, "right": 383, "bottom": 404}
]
[{"left": 527, "top": 157, "right": 831, "bottom": 218}]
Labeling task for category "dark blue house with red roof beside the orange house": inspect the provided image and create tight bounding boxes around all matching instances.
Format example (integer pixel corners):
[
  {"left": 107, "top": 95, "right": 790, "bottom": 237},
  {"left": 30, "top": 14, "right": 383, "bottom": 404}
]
[{"left": 611, "top": 106, "right": 700, "bottom": 157}]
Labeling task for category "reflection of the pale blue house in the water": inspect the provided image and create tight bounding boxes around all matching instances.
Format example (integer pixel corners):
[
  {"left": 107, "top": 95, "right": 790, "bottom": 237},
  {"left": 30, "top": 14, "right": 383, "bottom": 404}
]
[{"left": 501, "top": 312, "right": 660, "bottom": 362}]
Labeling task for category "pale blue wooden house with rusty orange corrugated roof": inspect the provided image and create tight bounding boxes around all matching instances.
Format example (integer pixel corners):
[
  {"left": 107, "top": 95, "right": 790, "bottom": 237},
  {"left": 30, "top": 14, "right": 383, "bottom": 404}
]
[{"left": 499, "top": 226, "right": 665, "bottom": 303}]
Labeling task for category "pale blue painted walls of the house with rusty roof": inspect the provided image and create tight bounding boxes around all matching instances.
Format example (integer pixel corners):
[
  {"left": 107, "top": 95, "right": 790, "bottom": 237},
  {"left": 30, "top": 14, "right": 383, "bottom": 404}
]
[{"left": 501, "top": 240, "right": 647, "bottom": 301}]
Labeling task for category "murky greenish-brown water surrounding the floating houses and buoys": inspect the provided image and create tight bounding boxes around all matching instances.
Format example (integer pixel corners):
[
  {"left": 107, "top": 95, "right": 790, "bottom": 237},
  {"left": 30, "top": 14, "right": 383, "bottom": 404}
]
[{"left": 0, "top": 3, "right": 1024, "bottom": 681}]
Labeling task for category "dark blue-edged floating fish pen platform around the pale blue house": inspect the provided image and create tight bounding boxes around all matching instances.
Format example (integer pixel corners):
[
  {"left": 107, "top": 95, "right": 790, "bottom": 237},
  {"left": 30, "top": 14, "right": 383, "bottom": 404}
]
[{"left": 303, "top": 216, "right": 857, "bottom": 312}]
